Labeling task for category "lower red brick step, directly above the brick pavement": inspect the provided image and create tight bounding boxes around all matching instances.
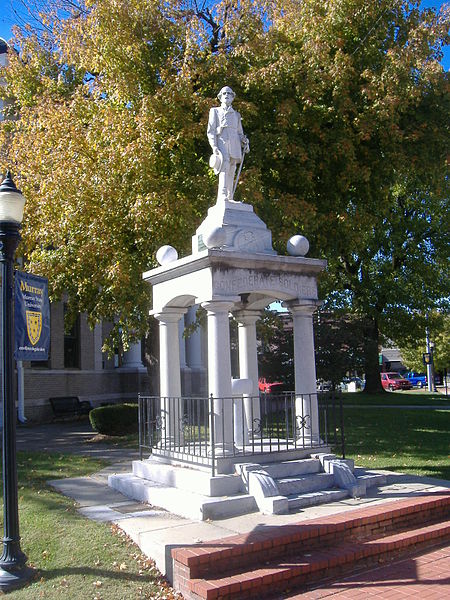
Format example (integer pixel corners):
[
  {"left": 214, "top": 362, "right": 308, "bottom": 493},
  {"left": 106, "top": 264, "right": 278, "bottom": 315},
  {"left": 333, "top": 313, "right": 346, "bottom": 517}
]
[{"left": 185, "top": 520, "right": 450, "bottom": 600}]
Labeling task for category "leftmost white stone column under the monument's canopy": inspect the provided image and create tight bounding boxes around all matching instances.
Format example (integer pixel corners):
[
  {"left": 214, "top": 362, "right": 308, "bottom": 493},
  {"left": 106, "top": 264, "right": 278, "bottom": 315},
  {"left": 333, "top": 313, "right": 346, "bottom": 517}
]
[{"left": 153, "top": 308, "right": 186, "bottom": 447}]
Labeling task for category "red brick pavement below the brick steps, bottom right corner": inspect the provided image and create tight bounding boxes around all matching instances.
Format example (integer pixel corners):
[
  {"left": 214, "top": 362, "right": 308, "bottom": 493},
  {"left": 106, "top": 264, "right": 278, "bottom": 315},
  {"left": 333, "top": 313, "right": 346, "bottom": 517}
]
[{"left": 283, "top": 546, "right": 450, "bottom": 600}]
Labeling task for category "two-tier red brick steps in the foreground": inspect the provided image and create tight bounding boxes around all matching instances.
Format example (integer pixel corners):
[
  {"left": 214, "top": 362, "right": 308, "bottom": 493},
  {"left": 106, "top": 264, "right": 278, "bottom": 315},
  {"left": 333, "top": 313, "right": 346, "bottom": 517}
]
[{"left": 172, "top": 492, "right": 450, "bottom": 600}]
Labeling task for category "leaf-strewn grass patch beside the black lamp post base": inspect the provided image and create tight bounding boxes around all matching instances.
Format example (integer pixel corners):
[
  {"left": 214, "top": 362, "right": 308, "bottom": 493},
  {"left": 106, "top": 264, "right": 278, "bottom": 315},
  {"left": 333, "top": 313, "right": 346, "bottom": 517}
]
[{"left": 2, "top": 453, "right": 181, "bottom": 600}]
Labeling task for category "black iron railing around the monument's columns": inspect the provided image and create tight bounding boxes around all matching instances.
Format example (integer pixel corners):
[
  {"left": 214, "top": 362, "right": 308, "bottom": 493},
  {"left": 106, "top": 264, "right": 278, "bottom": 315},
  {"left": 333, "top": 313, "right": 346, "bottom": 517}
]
[{"left": 139, "top": 392, "right": 345, "bottom": 472}]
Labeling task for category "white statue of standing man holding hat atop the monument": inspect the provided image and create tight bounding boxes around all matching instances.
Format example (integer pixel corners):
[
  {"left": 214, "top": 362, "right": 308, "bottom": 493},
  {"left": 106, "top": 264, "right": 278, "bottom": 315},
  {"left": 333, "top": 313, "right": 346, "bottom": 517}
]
[{"left": 207, "top": 86, "right": 249, "bottom": 202}]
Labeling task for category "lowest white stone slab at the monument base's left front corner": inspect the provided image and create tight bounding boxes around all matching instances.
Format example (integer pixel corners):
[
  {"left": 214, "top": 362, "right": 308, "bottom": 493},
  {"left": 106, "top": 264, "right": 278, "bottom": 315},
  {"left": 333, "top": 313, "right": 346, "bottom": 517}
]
[{"left": 108, "top": 473, "right": 258, "bottom": 521}]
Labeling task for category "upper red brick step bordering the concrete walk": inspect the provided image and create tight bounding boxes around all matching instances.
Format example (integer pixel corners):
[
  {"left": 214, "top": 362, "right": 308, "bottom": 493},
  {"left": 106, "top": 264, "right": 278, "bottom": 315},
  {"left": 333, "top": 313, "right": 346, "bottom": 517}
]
[{"left": 172, "top": 492, "right": 450, "bottom": 579}]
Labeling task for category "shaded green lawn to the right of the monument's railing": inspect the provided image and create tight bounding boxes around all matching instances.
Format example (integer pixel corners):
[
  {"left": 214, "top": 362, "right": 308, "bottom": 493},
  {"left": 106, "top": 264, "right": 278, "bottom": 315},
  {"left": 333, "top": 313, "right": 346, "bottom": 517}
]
[{"left": 344, "top": 406, "right": 450, "bottom": 481}]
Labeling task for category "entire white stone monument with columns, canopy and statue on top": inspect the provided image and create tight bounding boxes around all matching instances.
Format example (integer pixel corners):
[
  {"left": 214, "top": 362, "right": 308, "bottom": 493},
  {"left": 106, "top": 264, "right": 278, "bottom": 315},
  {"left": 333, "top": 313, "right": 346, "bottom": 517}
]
[{"left": 110, "top": 86, "right": 380, "bottom": 519}]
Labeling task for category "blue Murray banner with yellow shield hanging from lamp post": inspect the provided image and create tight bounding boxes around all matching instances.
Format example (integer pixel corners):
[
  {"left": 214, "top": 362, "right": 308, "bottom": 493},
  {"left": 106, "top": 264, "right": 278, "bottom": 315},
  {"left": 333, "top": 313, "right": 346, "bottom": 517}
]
[{"left": 14, "top": 271, "right": 50, "bottom": 360}]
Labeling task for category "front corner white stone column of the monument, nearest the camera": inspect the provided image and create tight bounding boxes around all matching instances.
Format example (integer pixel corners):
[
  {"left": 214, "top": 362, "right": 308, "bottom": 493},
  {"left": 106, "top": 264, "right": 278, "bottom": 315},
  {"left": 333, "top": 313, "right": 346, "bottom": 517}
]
[{"left": 202, "top": 300, "right": 236, "bottom": 456}]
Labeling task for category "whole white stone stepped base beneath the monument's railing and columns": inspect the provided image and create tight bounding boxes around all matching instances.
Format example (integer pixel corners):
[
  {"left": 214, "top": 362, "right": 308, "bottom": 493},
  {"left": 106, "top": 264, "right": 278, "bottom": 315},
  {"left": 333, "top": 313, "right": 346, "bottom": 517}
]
[{"left": 108, "top": 453, "right": 386, "bottom": 521}]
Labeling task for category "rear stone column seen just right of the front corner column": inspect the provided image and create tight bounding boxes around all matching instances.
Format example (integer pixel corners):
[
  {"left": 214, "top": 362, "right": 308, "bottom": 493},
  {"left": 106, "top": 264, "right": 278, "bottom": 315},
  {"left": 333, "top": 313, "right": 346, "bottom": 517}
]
[{"left": 234, "top": 310, "right": 261, "bottom": 439}]
